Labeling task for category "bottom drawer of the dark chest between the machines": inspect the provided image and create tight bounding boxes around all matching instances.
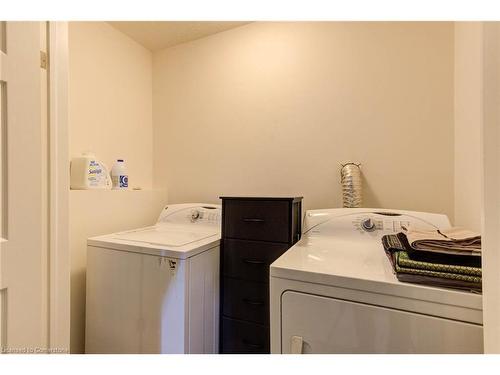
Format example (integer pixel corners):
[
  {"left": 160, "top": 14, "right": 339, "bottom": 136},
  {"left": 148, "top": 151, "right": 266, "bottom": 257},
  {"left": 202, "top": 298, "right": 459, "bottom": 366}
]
[{"left": 222, "top": 318, "right": 269, "bottom": 354}]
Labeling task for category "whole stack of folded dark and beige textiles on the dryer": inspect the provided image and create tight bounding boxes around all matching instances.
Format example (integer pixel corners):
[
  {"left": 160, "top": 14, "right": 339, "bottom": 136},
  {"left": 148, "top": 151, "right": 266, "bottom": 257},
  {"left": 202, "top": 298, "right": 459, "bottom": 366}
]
[{"left": 382, "top": 228, "right": 482, "bottom": 291}]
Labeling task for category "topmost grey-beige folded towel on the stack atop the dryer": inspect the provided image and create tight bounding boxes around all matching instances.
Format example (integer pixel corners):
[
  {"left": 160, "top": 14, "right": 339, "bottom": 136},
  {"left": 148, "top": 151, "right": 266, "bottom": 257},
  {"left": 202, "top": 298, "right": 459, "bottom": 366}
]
[{"left": 404, "top": 227, "right": 481, "bottom": 256}]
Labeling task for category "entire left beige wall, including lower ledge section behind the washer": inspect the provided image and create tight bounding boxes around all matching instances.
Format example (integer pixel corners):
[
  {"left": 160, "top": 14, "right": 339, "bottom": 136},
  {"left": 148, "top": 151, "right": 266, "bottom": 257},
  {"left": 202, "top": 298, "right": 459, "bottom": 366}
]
[{"left": 69, "top": 22, "right": 166, "bottom": 353}]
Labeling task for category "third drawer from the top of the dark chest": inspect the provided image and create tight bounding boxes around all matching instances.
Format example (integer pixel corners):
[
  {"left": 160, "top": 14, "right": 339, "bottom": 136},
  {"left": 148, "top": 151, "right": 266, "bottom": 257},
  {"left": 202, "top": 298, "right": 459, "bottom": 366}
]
[{"left": 222, "top": 277, "right": 269, "bottom": 325}]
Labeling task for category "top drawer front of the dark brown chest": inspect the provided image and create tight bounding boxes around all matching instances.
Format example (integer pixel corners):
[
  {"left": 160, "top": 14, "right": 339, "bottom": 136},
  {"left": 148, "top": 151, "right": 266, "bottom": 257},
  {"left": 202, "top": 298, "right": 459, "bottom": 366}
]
[{"left": 223, "top": 200, "right": 290, "bottom": 242}]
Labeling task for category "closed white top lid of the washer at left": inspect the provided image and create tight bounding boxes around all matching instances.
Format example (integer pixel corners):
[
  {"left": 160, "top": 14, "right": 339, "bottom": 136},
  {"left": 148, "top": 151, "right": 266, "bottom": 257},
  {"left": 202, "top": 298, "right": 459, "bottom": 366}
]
[{"left": 112, "top": 225, "right": 219, "bottom": 247}]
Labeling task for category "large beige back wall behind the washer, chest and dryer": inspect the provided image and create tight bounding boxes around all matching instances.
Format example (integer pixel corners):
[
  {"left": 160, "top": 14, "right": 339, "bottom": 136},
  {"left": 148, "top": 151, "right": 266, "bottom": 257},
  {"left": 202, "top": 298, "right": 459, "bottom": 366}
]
[{"left": 153, "top": 22, "right": 454, "bottom": 219}]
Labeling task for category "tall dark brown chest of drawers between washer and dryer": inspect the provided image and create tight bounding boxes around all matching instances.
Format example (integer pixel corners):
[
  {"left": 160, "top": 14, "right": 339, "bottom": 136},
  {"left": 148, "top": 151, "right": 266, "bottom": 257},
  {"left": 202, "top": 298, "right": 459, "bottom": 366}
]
[{"left": 219, "top": 197, "right": 302, "bottom": 353}]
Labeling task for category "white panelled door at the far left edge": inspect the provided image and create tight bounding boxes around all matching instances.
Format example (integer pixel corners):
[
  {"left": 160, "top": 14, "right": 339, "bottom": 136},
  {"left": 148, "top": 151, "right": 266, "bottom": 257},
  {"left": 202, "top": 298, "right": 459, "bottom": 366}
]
[{"left": 0, "top": 21, "right": 49, "bottom": 353}]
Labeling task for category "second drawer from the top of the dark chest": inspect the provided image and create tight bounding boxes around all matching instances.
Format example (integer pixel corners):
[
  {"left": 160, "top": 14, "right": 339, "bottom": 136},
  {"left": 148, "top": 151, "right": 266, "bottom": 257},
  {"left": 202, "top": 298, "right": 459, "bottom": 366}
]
[{"left": 222, "top": 240, "right": 289, "bottom": 282}]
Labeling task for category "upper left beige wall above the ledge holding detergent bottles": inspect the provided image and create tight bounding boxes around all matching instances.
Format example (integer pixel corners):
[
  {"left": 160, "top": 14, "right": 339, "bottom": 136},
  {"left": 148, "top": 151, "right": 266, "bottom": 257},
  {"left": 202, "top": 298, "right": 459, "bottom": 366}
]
[{"left": 69, "top": 22, "right": 153, "bottom": 188}]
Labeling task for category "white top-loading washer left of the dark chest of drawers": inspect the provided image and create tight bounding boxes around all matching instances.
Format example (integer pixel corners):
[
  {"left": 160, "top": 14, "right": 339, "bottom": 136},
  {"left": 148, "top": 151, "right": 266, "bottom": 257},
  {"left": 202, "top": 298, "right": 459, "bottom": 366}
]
[{"left": 85, "top": 203, "right": 221, "bottom": 353}]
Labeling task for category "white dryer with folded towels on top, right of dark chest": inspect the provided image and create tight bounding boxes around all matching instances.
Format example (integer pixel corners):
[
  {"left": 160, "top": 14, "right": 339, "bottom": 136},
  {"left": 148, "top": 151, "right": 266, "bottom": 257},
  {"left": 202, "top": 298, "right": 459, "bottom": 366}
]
[{"left": 270, "top": 208, "right": 483, "bottom": 353}]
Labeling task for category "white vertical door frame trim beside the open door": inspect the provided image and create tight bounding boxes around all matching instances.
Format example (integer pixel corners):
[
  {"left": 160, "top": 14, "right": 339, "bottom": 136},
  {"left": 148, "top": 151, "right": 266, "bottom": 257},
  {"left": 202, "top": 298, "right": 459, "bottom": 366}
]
[{"left": 48, "top": 22, "right": 70, "bottom": 353}]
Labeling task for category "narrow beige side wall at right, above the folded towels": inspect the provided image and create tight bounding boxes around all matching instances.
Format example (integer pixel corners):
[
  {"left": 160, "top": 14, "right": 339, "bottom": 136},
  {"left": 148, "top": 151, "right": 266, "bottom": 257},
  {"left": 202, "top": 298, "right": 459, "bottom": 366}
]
[{"left": 455, "top": 22, "right": 483, "bottom": 231}]
